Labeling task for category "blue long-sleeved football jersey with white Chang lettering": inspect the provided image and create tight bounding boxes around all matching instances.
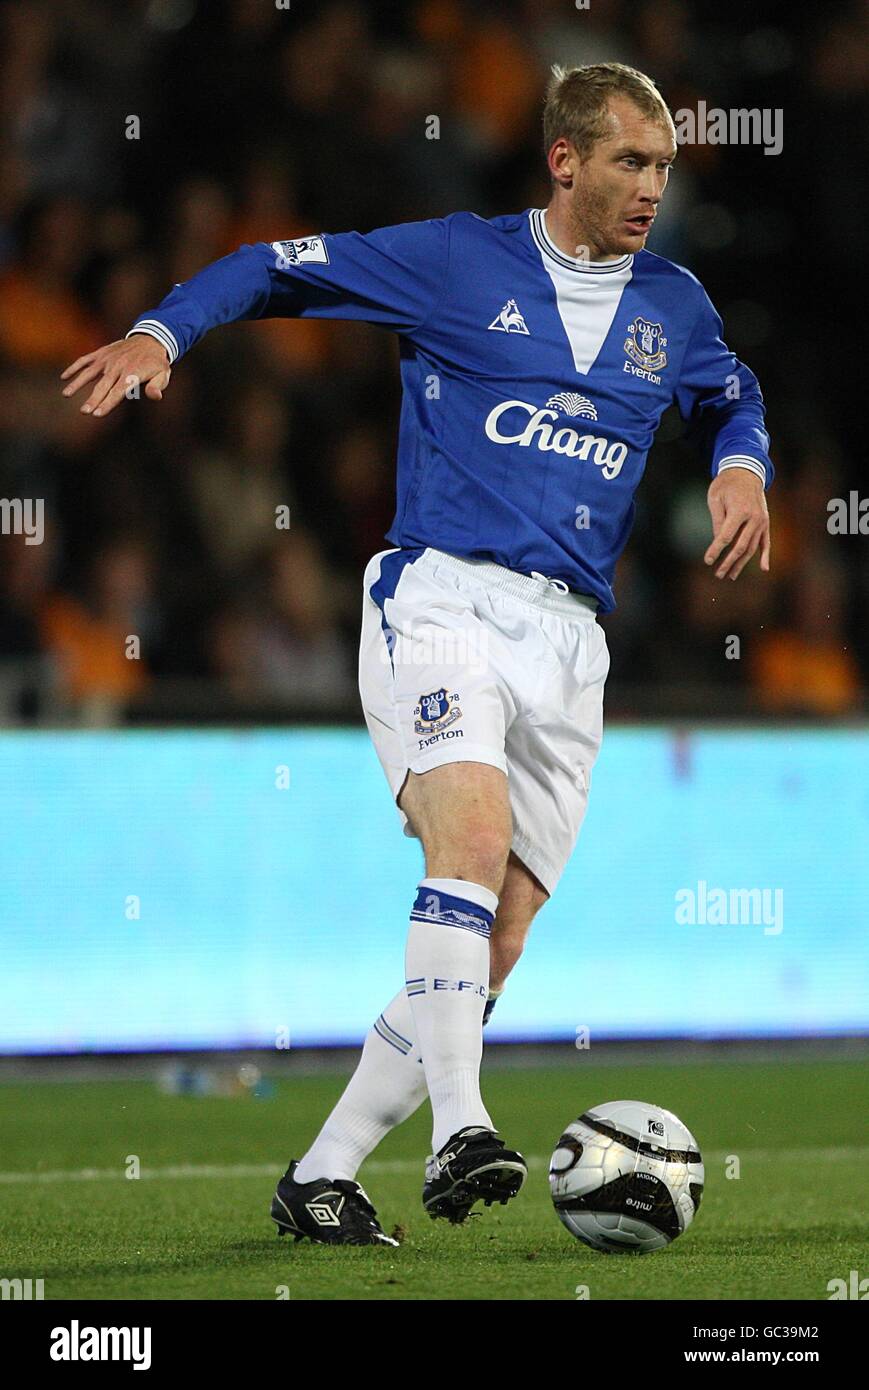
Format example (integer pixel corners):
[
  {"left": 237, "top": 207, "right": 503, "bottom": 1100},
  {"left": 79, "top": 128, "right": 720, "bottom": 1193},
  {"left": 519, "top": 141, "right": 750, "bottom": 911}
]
[{"left": 131, "top": 209, "right": 773, "bottom": 612}]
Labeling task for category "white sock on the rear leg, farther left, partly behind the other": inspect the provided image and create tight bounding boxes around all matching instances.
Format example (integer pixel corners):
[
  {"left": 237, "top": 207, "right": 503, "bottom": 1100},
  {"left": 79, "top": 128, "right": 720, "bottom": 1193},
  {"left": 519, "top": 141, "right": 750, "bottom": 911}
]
[{"left": 295, "top": 988, "right": 425, "bottom": 1183}]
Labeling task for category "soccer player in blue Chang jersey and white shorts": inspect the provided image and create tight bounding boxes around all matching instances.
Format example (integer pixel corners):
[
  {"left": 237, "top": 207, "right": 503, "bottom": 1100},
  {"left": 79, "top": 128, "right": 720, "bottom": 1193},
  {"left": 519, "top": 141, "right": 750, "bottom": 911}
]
[{"left": 64, "top": 63, "right": 773, "bottom": 1245}]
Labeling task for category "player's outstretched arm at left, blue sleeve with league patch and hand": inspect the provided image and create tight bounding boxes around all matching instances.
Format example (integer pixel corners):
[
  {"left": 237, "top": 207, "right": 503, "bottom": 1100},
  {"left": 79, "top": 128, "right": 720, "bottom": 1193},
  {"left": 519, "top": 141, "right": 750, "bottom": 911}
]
[{"left": 61, "top": 218, "right": 449, "bottom": 416}]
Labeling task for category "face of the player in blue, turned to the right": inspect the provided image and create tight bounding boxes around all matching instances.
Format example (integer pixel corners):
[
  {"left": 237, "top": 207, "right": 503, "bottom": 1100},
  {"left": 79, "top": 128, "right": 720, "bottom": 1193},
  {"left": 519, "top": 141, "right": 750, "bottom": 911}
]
[{"left": 570, "top": 97, "right": 676, "bottom": 260}]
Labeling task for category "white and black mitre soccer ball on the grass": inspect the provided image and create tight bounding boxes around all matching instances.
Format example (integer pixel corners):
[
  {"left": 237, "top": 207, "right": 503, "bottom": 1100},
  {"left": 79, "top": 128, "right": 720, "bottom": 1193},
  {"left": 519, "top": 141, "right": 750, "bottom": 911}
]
[{"left": 549, "top": 1101, "right": 704, "bottom": 1255}]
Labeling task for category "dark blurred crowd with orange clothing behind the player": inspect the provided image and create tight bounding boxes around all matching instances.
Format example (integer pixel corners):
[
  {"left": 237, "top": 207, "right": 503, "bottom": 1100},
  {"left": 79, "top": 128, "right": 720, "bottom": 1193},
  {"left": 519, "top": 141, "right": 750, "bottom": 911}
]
[{"left": 0, "top": 0, "right": 869, "bottom": 723}]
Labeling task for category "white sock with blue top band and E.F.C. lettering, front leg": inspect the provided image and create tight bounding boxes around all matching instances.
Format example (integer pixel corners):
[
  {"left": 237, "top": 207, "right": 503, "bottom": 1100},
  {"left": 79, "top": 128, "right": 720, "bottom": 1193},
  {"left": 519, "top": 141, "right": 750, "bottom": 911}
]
[{"left": 406, "top": 878, "right": 498, "bottom": 1154}]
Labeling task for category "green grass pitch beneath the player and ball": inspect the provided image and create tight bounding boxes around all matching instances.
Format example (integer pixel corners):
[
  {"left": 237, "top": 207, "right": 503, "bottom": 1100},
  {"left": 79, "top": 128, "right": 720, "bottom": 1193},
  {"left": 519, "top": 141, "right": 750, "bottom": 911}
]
[{"left": 0, "top": 1054, "right": 869, "bottom": 1300}]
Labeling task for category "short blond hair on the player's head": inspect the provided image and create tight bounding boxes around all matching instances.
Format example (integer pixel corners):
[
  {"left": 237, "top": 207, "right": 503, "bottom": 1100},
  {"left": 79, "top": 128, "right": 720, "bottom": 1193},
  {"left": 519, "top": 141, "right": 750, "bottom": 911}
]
[{"left": 544, "top": 63, "right": 674, "bottom": 158}]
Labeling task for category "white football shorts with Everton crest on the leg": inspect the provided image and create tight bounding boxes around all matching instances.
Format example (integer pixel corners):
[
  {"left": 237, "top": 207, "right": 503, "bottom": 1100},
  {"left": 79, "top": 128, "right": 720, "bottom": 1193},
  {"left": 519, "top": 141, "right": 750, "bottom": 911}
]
[{"left": 359, "top": 548, "right": 609, "bottom": 894}]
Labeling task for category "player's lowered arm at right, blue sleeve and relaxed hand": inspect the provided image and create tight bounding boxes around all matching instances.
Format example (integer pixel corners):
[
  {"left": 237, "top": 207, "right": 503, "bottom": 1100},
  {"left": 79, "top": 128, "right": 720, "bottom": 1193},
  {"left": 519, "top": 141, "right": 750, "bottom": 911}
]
[{"left": 676, "top": 291, "right": 774, "bottom": 580}]
